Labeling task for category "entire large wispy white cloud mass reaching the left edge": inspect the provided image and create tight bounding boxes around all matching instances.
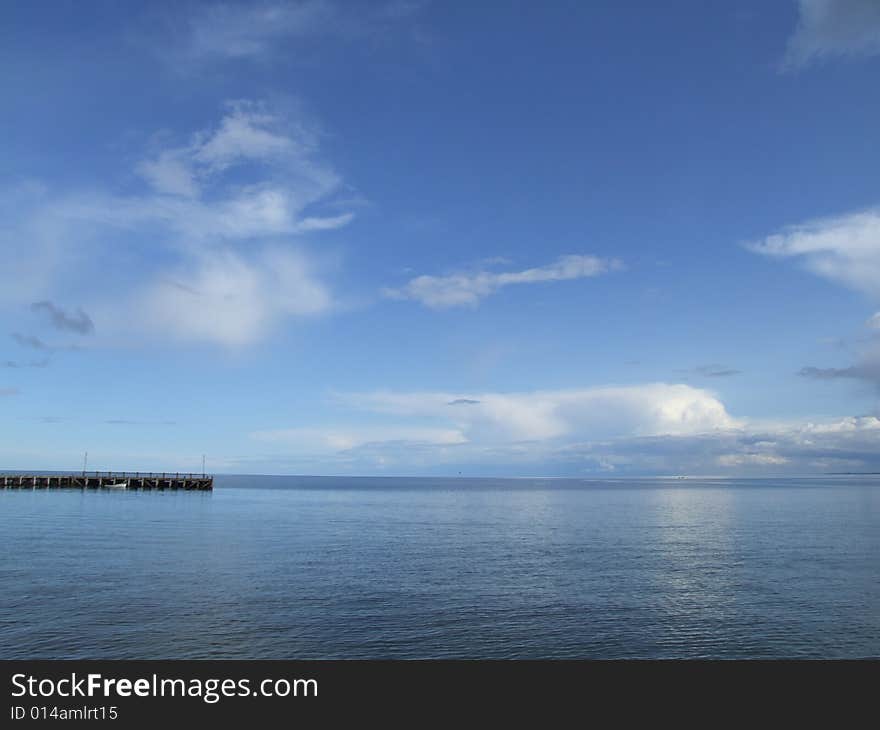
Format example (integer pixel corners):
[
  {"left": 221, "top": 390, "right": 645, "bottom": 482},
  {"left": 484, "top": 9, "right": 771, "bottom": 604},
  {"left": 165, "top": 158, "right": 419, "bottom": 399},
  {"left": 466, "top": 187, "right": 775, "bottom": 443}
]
[{"left": 0, "top": 102, "right": 353, "bottom": 347}]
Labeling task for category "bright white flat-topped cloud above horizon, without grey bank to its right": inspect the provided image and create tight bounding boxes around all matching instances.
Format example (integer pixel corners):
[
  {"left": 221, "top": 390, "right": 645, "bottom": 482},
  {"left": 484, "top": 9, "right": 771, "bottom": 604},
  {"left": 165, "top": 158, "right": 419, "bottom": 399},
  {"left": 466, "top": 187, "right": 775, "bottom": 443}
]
[{"left": 252, "top": 383, "right": 740, "bottom": 470}]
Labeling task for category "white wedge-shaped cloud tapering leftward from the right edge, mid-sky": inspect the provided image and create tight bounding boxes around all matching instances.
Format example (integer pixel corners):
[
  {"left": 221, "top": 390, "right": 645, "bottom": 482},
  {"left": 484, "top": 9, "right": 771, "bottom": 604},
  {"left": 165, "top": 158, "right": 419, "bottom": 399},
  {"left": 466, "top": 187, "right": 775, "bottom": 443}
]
[{"left": 750, "top": 203, "right": 880, "bottom": 298}]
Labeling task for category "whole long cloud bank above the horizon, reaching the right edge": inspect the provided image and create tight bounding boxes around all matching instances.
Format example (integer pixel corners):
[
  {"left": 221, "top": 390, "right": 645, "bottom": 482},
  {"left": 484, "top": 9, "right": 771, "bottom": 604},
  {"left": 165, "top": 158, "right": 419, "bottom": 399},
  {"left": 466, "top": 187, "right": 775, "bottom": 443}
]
[{"left": 244, "top": 384, "right": 880, "bottom": 476}]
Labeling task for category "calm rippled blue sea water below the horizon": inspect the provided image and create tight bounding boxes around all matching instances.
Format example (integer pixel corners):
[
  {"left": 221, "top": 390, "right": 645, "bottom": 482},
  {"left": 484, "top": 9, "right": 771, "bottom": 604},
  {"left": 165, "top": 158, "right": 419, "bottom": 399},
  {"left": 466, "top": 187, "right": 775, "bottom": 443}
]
[{"left": 0, "top": 477, "right": 880, "bottom": 659}]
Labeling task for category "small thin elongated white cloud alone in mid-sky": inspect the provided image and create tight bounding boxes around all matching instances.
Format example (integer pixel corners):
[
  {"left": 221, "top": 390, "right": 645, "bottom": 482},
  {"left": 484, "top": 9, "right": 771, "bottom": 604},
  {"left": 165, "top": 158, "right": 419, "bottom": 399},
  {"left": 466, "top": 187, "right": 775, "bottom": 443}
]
[{"left": 383, "top": 255, "right": 622, "bottom": 309}]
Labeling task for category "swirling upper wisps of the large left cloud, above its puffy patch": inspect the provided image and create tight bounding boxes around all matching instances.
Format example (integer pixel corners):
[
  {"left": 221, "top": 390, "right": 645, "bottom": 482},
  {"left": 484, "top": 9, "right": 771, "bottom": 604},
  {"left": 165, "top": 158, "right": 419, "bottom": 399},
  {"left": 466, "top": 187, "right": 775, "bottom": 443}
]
[{"left": 125, "top": 101, "right": 353, "bottom": 238}]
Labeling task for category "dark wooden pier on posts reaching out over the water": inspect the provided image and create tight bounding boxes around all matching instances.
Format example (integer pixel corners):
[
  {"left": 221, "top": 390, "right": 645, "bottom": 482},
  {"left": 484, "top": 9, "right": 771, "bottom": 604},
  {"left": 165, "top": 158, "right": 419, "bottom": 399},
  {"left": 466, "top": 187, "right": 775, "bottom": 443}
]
[{"left": 0, "top": 471, "right": 214, "bottom": 492}]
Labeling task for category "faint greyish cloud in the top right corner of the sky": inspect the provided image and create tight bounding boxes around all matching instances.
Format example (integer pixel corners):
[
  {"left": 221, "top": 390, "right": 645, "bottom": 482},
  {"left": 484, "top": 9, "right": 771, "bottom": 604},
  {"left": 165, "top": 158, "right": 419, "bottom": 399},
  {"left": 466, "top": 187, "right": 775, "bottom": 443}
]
[{"left": 785, "top": 0, "right": 880, "bottom": 69}]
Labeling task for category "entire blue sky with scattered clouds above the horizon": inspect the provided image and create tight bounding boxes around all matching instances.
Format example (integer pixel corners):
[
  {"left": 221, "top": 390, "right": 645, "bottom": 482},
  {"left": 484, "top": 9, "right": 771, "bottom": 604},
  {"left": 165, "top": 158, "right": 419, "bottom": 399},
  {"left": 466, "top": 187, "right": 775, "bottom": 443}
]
[{"left": 0, "top": 0, "right": 880, "bottom": 478}]
